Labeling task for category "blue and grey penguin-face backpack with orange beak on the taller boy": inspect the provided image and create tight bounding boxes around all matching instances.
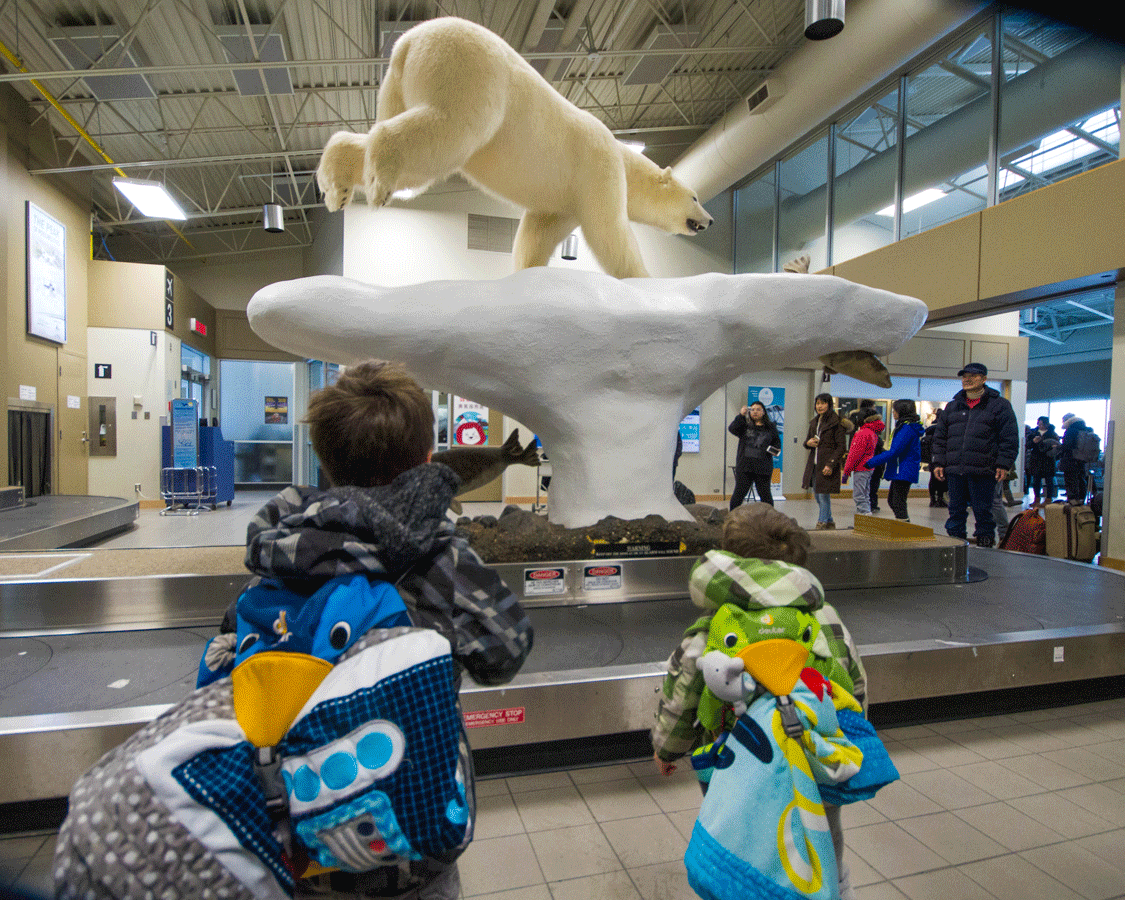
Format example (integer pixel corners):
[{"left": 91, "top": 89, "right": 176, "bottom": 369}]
[{"left": 55, "top": 575, "right": 474, "bottom": 900}]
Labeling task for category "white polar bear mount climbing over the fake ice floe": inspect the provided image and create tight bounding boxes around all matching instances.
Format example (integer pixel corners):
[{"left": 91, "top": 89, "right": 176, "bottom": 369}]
[{"left": 316, "top": 17, "right": 712, "bottom": 278}]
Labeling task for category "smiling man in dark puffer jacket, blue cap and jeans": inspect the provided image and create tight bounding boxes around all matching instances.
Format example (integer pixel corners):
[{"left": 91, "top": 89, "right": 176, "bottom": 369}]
[{"left": 933, "top": 362, "right": 1019, "bottom": 547}]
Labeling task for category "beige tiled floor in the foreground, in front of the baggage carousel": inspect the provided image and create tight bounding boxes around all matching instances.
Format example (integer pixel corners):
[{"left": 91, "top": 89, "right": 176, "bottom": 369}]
[{"left": 0, "top": 699, "right": 1125, "bottom": 900}]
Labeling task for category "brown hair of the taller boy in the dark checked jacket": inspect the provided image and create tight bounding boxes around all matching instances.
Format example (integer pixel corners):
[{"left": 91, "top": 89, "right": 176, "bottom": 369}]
[{"left": 305, "top": 359, "right": 433, "bottom": 487}]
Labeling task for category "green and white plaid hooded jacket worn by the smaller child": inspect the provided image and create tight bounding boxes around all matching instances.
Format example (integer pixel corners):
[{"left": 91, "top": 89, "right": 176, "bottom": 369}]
[{"left": 653, "top": 550, "right": 867, "bottom": 763}]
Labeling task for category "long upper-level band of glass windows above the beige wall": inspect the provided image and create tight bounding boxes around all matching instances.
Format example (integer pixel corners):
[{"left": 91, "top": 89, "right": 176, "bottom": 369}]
[{"left": 734, "top": 10, "right": 1125, "bottom": 279}]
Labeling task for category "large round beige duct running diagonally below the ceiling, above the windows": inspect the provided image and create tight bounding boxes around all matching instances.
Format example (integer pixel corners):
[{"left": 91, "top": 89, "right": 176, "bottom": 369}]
[{"left": 673, "top": 0, "right": 986, "bottom": 201}]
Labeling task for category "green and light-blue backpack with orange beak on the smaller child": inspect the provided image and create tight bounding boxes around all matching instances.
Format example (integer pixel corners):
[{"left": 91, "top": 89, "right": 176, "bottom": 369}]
[{"left": 684, "top": 604, "right": 864, "bottom": 900}]
